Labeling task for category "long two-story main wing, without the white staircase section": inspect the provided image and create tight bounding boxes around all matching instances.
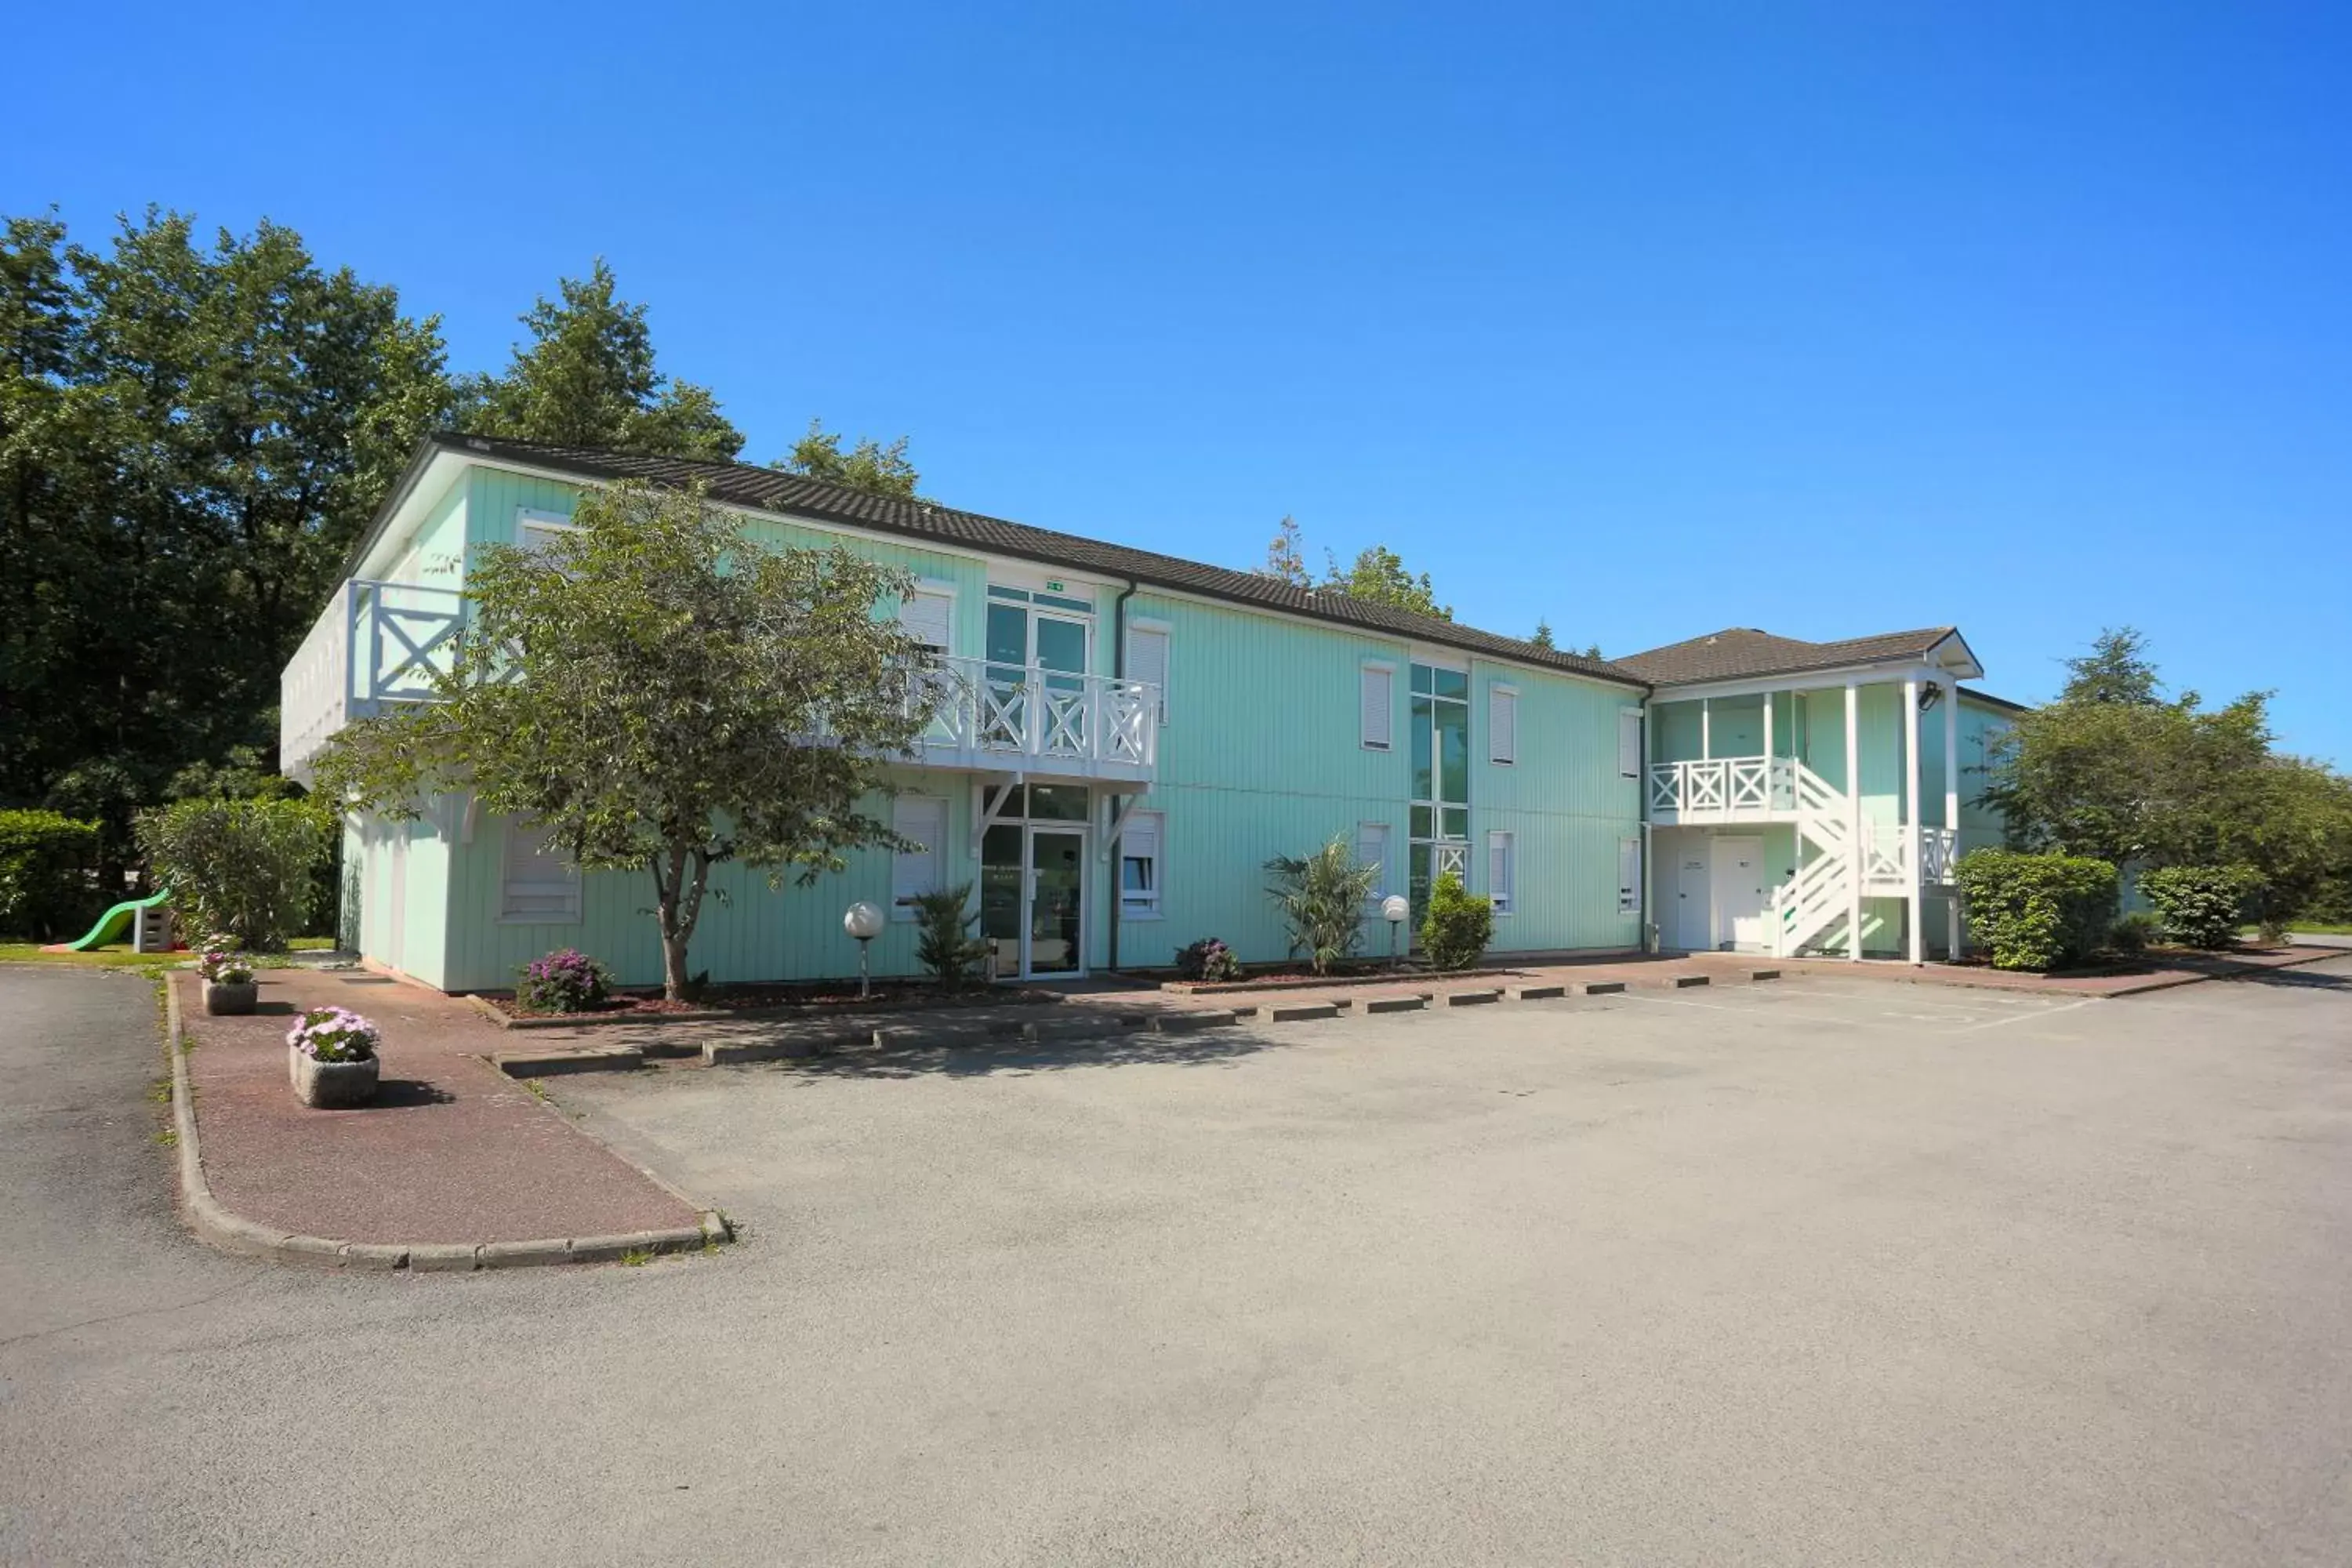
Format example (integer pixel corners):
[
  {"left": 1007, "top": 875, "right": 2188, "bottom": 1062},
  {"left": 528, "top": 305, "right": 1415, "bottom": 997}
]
[{"left": 280, "top": 435, "right": 1649, "bottom": 989}]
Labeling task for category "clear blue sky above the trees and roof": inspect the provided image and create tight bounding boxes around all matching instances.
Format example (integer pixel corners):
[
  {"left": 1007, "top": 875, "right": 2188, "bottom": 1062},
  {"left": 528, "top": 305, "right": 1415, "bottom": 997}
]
[{"left": 0, "top": 2, "right": 2352, "bottom": 764}]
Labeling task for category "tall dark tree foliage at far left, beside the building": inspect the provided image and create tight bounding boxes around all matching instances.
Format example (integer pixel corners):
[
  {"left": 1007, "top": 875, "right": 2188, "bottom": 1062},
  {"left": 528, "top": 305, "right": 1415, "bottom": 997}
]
[{"left": 0, "top": 209, "right": 452, "bottom": 867}]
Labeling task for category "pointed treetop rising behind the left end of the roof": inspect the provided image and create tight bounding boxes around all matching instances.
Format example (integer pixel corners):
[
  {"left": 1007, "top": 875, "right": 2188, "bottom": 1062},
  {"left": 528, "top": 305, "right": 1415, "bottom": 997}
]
[{"left": 461, "top": 256, "right": 743, "bottom": 459}]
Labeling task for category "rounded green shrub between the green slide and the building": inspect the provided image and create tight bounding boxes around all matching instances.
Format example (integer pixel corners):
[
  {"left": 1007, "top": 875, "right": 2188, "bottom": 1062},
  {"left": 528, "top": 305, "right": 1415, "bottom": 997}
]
[{"left": 139, "top": 799, "right": 334, "bottom": 952}]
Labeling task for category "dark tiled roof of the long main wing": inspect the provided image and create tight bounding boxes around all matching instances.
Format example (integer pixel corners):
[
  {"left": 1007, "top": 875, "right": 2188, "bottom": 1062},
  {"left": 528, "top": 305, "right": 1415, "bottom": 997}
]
[{"left": 414, "top": 435, "right": 1649, "bottom": 687}]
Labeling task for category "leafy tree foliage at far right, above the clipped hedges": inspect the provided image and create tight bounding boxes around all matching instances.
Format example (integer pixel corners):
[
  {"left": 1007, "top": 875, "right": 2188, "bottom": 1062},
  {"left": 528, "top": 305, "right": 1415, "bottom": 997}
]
[{"left": 1985, "top": 628, "right": 2352, "bottom": 919}]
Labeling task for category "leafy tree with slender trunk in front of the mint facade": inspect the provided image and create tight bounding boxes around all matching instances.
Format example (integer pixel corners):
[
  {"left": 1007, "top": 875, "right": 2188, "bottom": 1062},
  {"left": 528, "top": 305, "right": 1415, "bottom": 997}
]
[{"left": 318, "top": 485, "right": 929, "bottom": 996}]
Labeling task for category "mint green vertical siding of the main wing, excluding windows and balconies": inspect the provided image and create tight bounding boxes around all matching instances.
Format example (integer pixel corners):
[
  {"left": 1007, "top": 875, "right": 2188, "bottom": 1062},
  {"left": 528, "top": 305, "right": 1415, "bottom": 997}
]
[{"left": 355, "top": 468, "right": 1639, "bottom": 989}]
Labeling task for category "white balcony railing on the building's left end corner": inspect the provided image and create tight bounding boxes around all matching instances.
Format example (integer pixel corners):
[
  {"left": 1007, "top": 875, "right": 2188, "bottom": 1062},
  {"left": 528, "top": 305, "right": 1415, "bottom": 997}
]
[{"left": 278, "top": 579, "right": 466, "bottom": 783}]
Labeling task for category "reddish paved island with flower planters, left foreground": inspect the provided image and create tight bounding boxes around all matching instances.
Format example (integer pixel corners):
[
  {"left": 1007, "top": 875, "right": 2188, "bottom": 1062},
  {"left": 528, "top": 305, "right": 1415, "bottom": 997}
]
[{"left": 169, "top": 968, "right": 696, "bottom": 1243}]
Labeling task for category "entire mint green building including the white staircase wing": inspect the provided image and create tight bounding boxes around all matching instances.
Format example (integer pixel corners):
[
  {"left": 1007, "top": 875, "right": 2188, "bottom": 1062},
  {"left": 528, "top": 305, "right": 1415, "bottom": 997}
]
[{"left": 280, "top": 435, "right": 2009, "bottom": 992}]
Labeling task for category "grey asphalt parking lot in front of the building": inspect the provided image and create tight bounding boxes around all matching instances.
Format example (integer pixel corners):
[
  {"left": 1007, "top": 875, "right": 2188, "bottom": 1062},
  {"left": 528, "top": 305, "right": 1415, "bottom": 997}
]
[{"left": 0, "top": 959, "right": 2352, "bottom": 1566}]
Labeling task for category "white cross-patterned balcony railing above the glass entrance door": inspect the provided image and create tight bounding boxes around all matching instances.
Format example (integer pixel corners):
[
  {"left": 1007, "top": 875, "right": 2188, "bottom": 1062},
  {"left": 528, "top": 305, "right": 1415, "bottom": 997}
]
[{"left": 922, "top": 659, "right": 1160, "bottom": 781}]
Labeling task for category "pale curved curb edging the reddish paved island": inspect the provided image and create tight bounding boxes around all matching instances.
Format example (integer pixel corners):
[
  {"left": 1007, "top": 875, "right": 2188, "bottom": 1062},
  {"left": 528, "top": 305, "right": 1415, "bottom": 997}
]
[{"left": 162, "top": 982, "right": 734, "bottom": 1274}]
